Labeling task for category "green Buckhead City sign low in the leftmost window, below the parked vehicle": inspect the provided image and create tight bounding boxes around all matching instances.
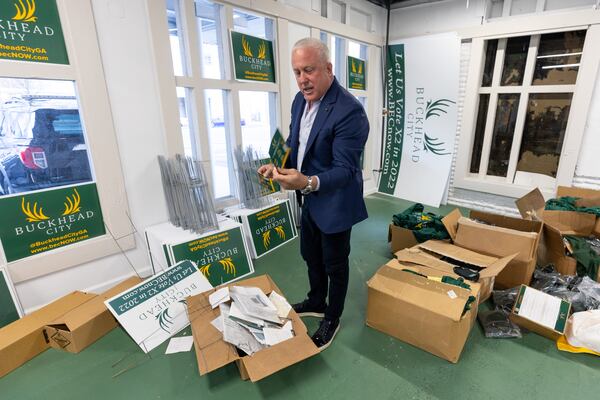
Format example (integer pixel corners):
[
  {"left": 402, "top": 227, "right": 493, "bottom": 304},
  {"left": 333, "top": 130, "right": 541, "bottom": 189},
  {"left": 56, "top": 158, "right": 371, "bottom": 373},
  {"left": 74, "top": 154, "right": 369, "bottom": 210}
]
[{"left": 0, "top": 183, "right": 106, "bottom": 262}]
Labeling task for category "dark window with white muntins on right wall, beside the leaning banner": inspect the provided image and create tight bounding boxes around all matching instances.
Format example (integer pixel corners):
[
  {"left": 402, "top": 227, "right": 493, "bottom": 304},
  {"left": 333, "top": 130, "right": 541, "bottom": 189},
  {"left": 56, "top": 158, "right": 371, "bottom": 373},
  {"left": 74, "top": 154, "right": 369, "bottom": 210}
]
[{"left": 459, "top": 30, "right": 586, "bottom": 194}]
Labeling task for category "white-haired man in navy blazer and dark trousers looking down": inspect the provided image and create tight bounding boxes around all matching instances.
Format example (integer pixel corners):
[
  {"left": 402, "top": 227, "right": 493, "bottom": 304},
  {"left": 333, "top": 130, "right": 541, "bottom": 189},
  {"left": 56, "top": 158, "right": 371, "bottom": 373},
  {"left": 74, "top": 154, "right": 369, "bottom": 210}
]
[{"left": 258, "top": 38, "right": 369, "bottom": 349}]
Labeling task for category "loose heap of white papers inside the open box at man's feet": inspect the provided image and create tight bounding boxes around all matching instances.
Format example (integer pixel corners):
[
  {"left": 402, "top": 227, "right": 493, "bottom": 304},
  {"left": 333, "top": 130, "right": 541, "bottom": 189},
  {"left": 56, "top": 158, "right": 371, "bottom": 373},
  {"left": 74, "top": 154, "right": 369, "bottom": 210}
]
[{"left": 209, "top": 286, "right": 294, "bottom": 355}]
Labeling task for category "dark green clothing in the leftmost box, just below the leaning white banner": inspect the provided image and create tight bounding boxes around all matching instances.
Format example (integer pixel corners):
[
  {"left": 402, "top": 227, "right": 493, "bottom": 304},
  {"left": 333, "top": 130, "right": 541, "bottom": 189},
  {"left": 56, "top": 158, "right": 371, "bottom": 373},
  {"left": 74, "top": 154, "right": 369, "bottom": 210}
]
[{"left": 392, "top": 203, "right": 450, "bottom": 243}]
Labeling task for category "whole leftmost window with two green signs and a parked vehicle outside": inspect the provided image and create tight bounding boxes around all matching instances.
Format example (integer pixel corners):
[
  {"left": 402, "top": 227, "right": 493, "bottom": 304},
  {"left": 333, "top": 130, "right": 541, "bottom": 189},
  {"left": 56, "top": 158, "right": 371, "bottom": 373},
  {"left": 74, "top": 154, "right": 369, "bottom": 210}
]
[{"left": 0, "top": 1, "right": 135, "bottom": 282}]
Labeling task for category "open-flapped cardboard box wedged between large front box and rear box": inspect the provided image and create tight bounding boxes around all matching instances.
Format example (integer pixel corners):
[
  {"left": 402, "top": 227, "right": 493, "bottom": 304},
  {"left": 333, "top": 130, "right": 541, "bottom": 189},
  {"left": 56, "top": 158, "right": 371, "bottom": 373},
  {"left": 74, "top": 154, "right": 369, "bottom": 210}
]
[{"left": 395, "top": 240, "right": 516, "bottom": 303}]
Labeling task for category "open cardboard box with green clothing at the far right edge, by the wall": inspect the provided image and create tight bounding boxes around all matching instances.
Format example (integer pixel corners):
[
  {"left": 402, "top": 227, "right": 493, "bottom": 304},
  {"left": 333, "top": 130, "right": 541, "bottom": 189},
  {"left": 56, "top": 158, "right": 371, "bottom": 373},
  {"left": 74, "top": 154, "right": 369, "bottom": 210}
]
[{"left": 516, "top": 186, "right": 600, "bottom": 282}]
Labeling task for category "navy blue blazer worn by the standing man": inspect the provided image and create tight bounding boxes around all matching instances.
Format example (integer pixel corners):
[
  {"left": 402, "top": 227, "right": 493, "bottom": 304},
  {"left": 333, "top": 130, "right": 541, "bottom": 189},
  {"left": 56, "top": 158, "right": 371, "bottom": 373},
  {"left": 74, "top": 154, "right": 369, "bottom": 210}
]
[{"left": 287, "top": 78, "right": 369, "bottom": 234}]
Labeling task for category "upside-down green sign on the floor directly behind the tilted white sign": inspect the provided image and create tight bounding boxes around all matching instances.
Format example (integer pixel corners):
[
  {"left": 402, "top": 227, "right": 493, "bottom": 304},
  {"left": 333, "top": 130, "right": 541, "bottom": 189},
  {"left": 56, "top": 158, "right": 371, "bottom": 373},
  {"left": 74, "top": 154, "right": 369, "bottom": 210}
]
[{"left": 171, "top": 226, "right": 254, "bottom": 286}]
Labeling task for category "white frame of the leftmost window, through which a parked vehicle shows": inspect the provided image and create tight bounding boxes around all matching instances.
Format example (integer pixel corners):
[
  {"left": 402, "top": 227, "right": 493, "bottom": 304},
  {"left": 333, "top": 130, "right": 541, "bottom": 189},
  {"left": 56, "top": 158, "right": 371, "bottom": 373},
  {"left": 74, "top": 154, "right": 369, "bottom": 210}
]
[{"left": 0, "top": 0, "right": 135, "bottom": 283}]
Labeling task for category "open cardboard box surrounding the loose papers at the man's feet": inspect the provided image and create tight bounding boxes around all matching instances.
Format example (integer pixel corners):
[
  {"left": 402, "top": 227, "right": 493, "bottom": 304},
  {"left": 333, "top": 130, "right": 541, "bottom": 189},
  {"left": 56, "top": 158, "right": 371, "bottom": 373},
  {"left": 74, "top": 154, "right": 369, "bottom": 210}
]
[{"left": 187, "top": 275, "right": 319, "bottom": 382}]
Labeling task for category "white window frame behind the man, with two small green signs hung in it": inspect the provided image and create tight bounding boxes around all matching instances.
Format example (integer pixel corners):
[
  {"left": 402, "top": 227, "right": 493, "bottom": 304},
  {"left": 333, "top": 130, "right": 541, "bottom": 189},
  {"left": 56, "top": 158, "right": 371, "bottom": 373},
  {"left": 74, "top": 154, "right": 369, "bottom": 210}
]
[{"left": 146, "top": 0, "right": 385, "bottom": 209}]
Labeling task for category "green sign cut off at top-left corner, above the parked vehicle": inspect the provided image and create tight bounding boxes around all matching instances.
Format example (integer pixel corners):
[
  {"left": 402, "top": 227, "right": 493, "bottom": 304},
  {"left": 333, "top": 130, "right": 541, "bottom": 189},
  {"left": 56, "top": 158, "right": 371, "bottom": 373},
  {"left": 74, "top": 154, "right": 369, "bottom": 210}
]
[{"left": 0, "top": 0, "right": 69, "bottom": 64}]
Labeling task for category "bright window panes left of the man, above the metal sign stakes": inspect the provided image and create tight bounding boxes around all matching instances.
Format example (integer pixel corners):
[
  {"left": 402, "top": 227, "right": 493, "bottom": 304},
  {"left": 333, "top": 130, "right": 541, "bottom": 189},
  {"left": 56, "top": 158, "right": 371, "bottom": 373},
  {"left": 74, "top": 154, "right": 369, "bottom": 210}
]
[{"left": 165, "top": 0, "right": 279, "bottom": 206}]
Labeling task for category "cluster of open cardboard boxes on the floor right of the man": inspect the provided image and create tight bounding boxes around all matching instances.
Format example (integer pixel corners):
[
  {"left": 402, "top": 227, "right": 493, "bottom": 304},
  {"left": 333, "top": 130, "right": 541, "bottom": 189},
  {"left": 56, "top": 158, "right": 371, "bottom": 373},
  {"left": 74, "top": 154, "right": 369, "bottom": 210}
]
[{"left": 378, "top": 187, "right": 600, "bottom": 362}]
